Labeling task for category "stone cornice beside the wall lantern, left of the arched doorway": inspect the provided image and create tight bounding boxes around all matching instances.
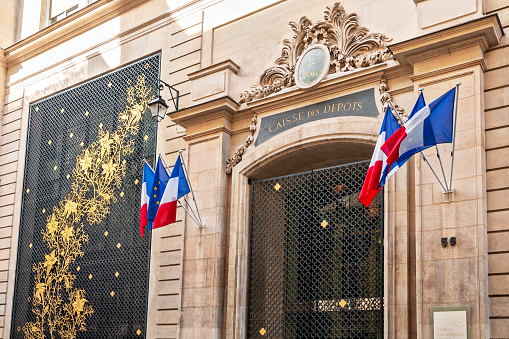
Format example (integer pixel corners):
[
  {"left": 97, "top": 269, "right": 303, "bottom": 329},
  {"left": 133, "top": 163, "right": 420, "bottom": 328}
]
[{"left": 169, "top": 96, "right": 240, "bottom": 128}]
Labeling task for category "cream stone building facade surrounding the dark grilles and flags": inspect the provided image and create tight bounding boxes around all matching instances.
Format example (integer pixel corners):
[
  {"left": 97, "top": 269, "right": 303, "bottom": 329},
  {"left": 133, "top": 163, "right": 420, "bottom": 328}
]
[{"left": 0, "top": 0, "right": 509, "bottom": 338}]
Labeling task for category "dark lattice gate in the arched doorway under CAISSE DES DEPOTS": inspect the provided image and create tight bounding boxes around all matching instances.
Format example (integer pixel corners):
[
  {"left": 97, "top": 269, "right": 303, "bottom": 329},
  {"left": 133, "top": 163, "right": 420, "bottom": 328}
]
[{"left": 249, "top": 162, "right": 383, "bottom": 339}]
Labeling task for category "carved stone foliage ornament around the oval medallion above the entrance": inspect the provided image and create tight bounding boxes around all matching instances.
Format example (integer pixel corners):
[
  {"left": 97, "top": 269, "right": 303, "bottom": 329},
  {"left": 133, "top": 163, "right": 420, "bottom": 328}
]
[{"left": 240, "top": 2, "right": 392, "bottom": 103}]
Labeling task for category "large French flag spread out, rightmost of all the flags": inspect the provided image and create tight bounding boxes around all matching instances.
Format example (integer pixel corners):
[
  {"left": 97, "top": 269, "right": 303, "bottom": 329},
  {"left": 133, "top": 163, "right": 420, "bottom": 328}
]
[{"left": 382, "top": 88, "right": 456, "bottom": 174}]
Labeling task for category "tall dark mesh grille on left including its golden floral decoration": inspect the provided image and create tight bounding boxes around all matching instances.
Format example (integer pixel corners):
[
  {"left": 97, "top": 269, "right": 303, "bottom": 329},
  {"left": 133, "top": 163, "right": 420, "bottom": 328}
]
[{"left": 11, "top": 55, "right": 160, "bottom": 339}]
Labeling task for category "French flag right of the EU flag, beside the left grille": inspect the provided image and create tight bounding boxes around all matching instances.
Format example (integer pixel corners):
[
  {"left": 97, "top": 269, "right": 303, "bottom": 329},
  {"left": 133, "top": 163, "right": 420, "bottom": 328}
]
[{"left": 152, "top": 156, "right": 191, "bottom": 228}]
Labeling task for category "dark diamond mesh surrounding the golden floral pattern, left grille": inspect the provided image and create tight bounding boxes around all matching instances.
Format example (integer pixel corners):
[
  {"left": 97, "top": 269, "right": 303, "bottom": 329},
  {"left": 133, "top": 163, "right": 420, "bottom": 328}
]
[{"left": 10, "top": 54, "right": 160, "bottom": 339}]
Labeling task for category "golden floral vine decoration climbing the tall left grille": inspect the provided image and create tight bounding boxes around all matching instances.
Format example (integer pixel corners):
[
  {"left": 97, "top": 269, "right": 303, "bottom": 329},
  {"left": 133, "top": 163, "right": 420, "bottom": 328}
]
[{"left": 23, "top": 75, "right": 153, "bottom": 339}]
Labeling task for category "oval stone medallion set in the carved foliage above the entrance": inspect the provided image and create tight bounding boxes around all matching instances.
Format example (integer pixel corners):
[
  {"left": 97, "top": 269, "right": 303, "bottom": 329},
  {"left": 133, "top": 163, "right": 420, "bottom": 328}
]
[{"left": 295, "top": 45, "right": 330, "bottom": 89}]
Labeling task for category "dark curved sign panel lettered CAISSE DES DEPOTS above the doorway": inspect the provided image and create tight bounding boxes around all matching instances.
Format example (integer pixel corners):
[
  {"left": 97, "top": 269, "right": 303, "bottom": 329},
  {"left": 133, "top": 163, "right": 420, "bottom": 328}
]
[{"left": 255, "top": 88, "right": 379, "bottom": 146}]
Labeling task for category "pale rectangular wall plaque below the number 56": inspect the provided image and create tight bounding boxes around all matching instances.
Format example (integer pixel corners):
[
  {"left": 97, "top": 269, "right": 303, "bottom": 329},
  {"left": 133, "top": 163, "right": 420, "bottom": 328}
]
[{"left": 430, "top": 306, "right": 471, "bottom": 339}]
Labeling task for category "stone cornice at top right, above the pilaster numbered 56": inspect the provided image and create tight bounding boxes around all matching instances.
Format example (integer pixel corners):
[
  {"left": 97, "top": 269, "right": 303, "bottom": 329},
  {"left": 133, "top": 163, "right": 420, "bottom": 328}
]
[{"left": 388, "top": 14, "right": 504, "bottom": 64}]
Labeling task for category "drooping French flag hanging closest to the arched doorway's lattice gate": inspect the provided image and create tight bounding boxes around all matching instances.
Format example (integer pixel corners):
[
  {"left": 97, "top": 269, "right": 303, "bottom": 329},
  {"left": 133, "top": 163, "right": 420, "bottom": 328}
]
[{"left": 359, "top": 107, "right": 399, "bottom": 207}]
